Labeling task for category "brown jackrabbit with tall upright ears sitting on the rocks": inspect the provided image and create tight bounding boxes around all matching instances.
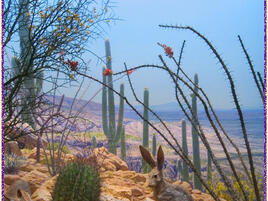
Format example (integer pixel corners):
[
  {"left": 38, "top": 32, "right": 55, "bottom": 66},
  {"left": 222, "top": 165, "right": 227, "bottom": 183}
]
[{"left": 140, "top": 146, "right": 194, "bottom": 201}]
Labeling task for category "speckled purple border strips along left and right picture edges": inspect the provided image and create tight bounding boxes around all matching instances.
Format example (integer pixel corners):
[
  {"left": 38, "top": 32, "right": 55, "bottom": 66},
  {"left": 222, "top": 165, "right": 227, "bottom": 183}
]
[{"left": 1, "top": 0, "right": 267, "bottom": 201}]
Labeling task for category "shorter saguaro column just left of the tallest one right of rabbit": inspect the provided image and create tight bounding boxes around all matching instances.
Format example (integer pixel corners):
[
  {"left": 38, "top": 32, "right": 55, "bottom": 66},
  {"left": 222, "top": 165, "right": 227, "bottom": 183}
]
[{"left": 181, "top": 119, "right": 189, "bottom": 182}]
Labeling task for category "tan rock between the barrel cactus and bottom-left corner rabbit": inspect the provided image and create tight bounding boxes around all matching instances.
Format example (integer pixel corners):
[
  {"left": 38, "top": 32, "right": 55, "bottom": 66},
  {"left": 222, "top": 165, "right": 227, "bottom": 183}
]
[{"left": 22, "top": 170, "right": 49, "bottom": 192}]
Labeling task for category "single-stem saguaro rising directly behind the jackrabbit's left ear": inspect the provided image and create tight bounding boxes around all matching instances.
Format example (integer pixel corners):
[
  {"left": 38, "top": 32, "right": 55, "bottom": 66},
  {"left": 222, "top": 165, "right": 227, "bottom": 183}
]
[{"left": 142, "top": 88, "right": 151, "bottom": 173}]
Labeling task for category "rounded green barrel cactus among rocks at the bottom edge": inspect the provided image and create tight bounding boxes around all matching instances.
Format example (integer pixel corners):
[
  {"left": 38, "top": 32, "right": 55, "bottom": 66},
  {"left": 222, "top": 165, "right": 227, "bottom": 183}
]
[{"left": 52, "top": 162, "right": 100, "bottom": 201}]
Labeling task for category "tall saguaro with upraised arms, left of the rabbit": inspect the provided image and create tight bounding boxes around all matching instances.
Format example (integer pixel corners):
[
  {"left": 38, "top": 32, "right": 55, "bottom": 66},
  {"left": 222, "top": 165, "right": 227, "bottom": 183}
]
[{"left": 102, "top": 39, "right": 124, "bottom": 154}]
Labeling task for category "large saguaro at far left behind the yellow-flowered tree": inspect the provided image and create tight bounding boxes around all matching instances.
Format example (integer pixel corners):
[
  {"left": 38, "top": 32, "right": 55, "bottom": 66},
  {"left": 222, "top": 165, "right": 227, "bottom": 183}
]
[{"left": 11, "top": 0, "right": 44, "bottom": 128}]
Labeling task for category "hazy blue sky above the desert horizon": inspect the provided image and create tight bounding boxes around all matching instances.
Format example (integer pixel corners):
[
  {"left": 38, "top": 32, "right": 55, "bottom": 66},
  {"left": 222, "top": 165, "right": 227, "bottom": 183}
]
[{"left": 56, "top": 0, "right": 264, "bottom": 109}]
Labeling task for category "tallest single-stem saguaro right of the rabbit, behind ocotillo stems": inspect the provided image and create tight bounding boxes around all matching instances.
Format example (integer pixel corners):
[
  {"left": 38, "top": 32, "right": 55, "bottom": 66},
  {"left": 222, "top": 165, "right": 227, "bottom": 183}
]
[{"left": 192, "top": 74, "right": 202, "bottom": 190}]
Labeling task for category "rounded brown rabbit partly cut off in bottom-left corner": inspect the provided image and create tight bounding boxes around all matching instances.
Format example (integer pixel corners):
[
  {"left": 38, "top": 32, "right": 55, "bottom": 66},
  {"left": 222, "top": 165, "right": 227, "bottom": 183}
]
[{"left": 4, "top": 180, "right": 32, "bottom": 201}]
